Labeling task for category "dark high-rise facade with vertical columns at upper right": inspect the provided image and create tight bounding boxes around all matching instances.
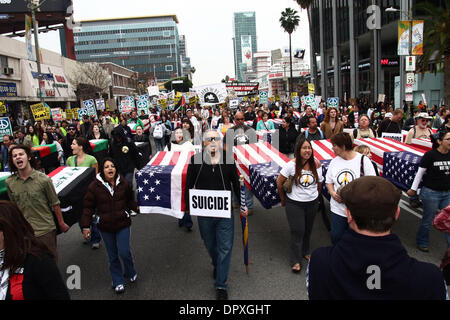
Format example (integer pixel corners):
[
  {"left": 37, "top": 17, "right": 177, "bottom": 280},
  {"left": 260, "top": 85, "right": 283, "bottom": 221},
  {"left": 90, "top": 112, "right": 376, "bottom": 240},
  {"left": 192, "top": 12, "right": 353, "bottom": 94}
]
[{"left": 310, "top": 0, "right": 442, "bottom": 107}]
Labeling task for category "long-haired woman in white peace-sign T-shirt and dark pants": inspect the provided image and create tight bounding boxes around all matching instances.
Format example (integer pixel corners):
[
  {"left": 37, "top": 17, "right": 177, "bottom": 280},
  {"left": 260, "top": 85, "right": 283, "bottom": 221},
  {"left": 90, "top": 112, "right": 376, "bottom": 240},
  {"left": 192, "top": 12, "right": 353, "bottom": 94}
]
[{"left": 277, "top": 137, "right": 324, "bottom": 273}]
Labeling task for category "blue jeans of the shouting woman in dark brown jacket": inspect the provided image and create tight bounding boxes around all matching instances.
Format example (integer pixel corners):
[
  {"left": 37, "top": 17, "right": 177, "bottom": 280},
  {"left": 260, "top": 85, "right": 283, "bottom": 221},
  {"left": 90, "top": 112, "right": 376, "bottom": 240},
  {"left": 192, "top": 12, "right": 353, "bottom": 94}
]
[{"left": 101, "top": 228, "right": 136, "bottom": 287}]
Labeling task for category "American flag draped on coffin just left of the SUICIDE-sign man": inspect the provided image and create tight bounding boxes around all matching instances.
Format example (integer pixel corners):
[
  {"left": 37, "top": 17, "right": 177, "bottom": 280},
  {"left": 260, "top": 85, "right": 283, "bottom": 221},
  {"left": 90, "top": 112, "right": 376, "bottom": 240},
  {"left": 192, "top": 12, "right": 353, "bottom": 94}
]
[{"left": 136, "top": 151, "right": 194, "bottom": 219}]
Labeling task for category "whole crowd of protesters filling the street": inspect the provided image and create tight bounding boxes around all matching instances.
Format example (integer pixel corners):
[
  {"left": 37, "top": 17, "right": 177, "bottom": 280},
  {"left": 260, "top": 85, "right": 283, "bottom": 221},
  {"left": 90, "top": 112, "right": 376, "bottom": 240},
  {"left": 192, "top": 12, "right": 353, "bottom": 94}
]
[{"left": 0, "top": 99, "right": 450, "bottom": 299}]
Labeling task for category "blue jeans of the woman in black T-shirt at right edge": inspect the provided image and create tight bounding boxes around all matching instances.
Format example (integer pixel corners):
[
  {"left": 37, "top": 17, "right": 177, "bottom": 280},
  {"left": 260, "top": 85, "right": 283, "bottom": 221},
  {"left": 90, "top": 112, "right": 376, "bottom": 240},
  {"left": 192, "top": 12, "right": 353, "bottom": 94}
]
[{"left": 416, "top": 187, "right": 450, "bottom": 247}]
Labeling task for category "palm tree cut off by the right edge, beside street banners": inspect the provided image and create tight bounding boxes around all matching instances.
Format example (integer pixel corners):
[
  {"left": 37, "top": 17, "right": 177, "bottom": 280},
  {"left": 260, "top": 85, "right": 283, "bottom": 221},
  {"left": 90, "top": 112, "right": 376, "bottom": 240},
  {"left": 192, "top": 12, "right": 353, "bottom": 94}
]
[{"left": 416, "top": 1, "right": 450, "bottom": 105}]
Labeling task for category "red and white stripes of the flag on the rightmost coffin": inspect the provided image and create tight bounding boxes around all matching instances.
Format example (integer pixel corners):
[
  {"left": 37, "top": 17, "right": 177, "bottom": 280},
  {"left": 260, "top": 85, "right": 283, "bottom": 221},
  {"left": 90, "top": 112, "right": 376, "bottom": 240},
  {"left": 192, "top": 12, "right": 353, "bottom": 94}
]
[{"left": 354, "top": 138, "right": 425, "bottom": 171}]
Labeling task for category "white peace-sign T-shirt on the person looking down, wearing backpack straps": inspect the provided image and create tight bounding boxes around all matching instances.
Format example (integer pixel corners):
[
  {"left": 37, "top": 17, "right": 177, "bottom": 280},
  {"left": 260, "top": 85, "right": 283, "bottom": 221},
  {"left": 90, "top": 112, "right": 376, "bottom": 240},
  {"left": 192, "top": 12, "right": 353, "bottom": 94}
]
[{"left": 325, "top": 153, "right": 376, "bottom": 217}]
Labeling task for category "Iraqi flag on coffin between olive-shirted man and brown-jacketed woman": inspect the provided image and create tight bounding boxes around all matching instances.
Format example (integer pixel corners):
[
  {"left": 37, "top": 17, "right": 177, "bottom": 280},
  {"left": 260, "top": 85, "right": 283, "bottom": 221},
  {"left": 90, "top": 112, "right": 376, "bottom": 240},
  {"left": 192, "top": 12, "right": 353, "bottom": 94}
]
[{"left": 48, "top": 167, "right": 95, "bottom": 230}]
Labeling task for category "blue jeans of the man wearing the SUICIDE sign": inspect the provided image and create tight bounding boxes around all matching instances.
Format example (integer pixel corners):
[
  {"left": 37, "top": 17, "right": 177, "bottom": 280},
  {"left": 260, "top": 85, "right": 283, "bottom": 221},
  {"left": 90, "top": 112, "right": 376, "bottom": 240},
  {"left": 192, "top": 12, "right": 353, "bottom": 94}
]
[{"left": 197, "top": 211, "right": 234, "bottom": 289}]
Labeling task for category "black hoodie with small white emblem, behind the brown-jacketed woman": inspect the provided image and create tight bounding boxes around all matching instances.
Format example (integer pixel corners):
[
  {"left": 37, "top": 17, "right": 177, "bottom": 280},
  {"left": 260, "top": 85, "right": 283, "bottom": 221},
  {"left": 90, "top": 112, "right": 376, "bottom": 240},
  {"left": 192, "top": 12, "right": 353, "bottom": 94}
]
[{"left": 109, "top": 126, "right": 140, "bottom": 175}]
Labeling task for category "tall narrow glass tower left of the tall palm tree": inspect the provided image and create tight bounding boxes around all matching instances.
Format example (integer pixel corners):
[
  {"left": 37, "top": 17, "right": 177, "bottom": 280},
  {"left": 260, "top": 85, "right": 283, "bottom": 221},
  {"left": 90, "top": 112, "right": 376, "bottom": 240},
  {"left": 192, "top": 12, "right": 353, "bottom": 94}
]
[{"left": 233, "top": 12, "right": 258, "bottom": 81}]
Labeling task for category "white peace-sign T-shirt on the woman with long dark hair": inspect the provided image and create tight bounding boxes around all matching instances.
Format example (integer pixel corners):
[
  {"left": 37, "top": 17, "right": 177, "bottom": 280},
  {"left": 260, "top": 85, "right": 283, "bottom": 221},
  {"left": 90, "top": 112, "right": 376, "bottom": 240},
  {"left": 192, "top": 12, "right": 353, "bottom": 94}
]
[{"left": 280, "top": 161, "right": 324, "bottom": 202}]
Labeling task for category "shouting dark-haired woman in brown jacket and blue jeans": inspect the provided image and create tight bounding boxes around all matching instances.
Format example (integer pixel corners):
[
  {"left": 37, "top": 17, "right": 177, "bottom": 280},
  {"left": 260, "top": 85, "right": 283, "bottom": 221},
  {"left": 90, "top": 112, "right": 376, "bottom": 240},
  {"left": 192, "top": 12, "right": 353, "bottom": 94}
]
[{"left": 81, "top": 158, "right": 138, "bottom": 294}]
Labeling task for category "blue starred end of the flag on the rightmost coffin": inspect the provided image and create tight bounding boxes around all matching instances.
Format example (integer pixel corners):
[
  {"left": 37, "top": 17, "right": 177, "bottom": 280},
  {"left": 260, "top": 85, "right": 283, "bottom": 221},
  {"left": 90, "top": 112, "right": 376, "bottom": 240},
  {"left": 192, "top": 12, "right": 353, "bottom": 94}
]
[{"left": 383, "top": 151, "right": 422, "bottom": 191}]
